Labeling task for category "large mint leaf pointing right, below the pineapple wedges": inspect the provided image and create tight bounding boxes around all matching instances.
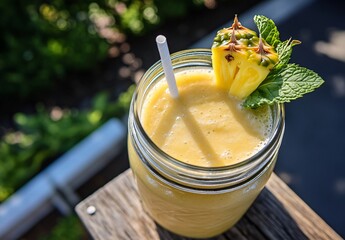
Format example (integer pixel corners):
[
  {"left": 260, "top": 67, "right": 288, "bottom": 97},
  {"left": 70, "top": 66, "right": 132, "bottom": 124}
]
[{"left": 243, "top": 64, "right": 324, "bottom": 108}]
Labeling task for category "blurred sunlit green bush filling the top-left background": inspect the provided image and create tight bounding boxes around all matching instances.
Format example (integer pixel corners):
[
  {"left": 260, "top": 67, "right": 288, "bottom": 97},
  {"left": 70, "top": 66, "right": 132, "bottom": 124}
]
[{"left": 0, "top": 0, "right": 203, "bottom": 101}]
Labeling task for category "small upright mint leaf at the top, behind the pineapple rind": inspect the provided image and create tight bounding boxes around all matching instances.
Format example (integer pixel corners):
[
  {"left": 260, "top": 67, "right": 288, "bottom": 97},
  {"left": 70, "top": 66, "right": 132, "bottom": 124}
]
[{"left": 254, "top": 15, "right": 281, "bottom": 48}]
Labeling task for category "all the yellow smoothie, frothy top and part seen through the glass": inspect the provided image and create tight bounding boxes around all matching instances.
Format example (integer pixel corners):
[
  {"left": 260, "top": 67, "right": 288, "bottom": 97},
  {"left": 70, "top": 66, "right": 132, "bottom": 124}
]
[{"left": 128, "top": 64, "right": 276, "bottom": 238}]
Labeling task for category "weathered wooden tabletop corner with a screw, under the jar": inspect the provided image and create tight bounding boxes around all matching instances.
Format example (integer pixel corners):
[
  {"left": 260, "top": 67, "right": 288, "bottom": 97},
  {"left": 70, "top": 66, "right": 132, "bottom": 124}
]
[{"left": 76, "top": 170, "right": 341, "bottom": 240}]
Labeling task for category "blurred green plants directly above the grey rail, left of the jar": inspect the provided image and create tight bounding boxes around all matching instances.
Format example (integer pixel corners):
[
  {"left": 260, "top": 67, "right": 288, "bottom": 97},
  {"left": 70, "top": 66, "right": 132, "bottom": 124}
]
[{"left": 0, "top": 86, "right": 134, "bottom": 202}]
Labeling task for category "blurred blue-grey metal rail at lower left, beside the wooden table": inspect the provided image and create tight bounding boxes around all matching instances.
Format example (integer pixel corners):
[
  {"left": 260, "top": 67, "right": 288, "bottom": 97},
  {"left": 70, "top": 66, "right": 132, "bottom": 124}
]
[{"left": 0, "top": 119, "right": 127, "bottom": 239}]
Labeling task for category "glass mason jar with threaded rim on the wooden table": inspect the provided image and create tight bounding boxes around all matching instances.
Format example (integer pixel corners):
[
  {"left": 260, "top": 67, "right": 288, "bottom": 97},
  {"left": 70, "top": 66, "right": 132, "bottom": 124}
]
[{"left": 128, "top": 49, "right": 285, "bottom": 238}]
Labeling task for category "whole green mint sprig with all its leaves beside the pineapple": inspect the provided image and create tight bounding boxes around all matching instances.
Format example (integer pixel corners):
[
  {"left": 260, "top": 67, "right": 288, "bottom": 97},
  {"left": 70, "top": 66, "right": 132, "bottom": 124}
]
[{"left": 243, "top": 15, "right": 324, "bottom": 108}]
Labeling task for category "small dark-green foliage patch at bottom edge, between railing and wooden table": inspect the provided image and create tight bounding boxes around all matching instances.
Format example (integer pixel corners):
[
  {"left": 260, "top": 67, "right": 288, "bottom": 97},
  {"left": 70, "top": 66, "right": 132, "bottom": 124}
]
[{"left": 39, "top": 215, "right": 85, "bottom": 240}]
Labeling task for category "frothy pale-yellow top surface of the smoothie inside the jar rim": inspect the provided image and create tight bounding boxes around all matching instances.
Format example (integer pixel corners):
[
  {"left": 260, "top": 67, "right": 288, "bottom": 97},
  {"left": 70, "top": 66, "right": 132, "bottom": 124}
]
[{"left": 141, "top": 69, "right": 272, "bottom": 167}]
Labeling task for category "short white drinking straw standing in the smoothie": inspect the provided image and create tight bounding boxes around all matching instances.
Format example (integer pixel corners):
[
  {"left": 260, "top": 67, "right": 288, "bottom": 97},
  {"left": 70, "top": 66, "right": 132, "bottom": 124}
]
[{"left": 156, "top": 35, "right": 178, "bottom": 98}]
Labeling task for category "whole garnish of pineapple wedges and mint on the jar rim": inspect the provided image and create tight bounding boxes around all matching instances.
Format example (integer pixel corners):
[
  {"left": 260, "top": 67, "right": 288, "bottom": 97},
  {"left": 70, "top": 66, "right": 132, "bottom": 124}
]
[{"left": 212, "top": 15, "right": 324, "bottom": 108}]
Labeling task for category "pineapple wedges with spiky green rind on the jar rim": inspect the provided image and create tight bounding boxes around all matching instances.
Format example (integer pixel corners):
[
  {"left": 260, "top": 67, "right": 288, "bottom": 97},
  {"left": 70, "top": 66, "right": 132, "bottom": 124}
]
[{"left": 212, "top": 16, "right": 278, "bottom": 99}]
